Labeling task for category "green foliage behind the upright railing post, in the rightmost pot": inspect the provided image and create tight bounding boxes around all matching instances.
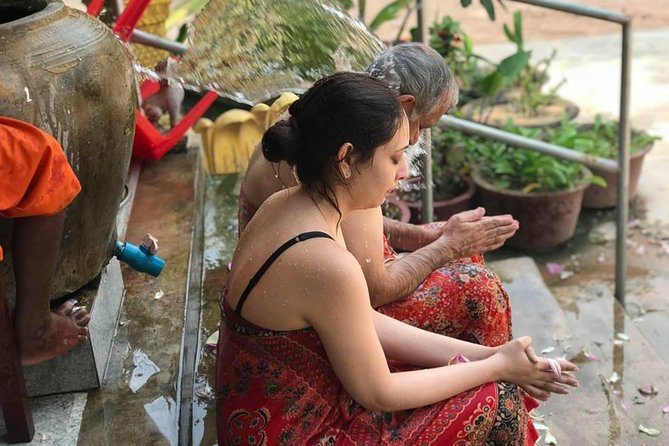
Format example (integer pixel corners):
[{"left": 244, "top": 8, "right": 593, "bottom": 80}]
[{"left": 543, "top": 115, "right": 662, "bottom": 158}]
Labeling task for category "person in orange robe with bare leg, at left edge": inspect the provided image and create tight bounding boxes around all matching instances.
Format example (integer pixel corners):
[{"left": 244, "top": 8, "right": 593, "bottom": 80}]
[{"left": 0, "top": 117, "right": 91, "bottom": 365}]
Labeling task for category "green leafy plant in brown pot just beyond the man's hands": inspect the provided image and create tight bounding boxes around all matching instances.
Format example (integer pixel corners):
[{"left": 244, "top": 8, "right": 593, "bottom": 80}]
[{"left": 465, "top": 123, "right": 602, "bottom": 252}]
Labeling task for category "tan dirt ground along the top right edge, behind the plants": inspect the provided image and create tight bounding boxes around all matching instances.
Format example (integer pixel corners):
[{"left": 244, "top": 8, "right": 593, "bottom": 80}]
[{"left": 366, "top": 0, "right": 669, "bottom": 44}]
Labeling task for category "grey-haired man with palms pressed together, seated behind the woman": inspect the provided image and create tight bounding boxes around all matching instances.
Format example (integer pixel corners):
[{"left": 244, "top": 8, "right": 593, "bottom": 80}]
[{"left": 239, "top": 43, "right": 518, "bottom": 346}]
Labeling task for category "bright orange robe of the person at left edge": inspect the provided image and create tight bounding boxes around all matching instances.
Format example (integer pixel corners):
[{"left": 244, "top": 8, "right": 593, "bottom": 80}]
[{"left": 0, "top": 116, "right": 81, "bottom": 261}]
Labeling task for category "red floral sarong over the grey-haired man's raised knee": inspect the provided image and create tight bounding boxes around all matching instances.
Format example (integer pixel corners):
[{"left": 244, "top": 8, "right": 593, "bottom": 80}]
[{"left": 377, "top": 235, "right": 511, "bottom": 347}]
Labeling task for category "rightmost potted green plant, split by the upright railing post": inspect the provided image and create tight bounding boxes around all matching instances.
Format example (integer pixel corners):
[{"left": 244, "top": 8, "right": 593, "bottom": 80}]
[{"left": 543, "top": 115, "right": 660, "bottom": 209}]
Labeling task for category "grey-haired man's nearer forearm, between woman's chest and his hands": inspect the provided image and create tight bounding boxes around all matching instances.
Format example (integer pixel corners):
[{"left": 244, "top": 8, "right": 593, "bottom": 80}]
[{"left": 369, "top": 239, "right": 453, "bottom": 307}]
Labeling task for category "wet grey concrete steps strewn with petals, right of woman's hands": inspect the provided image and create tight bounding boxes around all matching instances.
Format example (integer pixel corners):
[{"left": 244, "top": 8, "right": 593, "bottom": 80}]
[{"left": 491, "top": 257, "right": 669, "bottom": 445}]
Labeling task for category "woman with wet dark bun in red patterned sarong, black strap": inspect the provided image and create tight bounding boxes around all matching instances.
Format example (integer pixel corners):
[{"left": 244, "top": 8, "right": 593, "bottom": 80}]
[{"left": 216, "top": 73, "right": 578, "bottom": 445}]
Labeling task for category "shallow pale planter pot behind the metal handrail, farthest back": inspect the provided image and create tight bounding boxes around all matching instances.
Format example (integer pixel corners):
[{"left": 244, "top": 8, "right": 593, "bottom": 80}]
[{"left": 460, "top": 97, "right": 579, "bottom": 128}]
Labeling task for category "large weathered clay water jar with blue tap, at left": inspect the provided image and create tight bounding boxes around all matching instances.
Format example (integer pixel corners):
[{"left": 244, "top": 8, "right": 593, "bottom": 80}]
[{"left": 0, "top": 0, "right": 137, "bottom": 298}]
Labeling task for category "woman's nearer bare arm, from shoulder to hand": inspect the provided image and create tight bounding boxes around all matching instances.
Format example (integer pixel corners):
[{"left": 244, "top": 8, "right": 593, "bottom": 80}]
[{"left": 301, "top": 250, "right": 568, "bottom": 411}]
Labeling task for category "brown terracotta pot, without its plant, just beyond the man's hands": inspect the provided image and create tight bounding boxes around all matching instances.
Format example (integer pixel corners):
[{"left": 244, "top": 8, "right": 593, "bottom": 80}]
[{"left": 472, "top": 167, "right": 590, "bottom": 252}]
